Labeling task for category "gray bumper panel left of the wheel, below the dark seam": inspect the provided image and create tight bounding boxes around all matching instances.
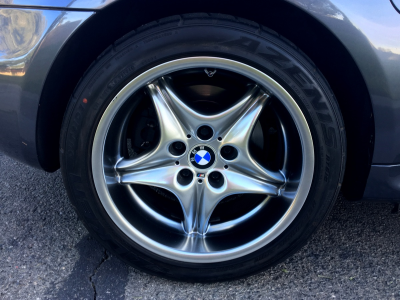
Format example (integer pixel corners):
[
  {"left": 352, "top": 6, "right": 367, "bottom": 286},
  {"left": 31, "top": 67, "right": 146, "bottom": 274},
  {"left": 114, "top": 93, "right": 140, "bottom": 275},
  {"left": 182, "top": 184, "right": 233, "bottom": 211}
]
[{"left": 0, "top": 8, "right": 93, "bottom": 167}]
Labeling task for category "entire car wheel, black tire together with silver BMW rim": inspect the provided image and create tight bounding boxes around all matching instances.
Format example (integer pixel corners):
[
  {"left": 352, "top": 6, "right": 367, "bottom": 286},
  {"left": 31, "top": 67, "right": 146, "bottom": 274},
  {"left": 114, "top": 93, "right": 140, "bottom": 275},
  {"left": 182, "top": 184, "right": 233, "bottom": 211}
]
[{"left": 60, "top": 14, "right": 346, "bottom": 282}]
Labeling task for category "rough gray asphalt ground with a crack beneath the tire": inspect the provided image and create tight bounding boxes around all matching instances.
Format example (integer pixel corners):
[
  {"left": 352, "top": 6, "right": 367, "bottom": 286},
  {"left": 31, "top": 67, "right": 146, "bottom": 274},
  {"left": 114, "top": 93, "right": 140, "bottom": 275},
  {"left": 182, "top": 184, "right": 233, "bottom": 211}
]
[{"left": 0, "top": 153, "right": 400, "bottom": 300}]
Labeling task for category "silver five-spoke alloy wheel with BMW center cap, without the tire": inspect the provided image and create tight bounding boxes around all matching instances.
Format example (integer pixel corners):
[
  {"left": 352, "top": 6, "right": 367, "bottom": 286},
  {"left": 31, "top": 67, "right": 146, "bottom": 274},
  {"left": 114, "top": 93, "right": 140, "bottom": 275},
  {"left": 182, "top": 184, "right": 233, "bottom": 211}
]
[{"left": 92, "top": 57, "right": 314, "bottom": 263}]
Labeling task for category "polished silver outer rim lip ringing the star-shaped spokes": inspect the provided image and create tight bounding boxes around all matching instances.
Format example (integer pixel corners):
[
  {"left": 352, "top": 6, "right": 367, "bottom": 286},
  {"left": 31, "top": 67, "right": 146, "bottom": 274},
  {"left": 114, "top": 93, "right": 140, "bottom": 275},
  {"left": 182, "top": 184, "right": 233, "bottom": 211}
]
[{"left": 91, "top": 56, "right": 314, "bottom": 263}]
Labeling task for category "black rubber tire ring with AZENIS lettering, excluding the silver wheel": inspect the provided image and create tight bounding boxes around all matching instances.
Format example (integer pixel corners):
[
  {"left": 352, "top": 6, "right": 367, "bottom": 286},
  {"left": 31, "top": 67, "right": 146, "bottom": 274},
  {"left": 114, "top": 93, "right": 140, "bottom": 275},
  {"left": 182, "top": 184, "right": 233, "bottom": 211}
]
[{"left": 60, "top": 13, "right": 346, "bottom": 282}]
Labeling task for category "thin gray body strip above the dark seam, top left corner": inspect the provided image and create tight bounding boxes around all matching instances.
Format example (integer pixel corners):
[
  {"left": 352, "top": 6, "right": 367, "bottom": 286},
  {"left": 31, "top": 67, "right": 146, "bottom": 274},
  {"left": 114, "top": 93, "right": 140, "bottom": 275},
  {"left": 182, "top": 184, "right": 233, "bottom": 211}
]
[{"left": 0, "top": 0, "right": 116, "bottom": 9}]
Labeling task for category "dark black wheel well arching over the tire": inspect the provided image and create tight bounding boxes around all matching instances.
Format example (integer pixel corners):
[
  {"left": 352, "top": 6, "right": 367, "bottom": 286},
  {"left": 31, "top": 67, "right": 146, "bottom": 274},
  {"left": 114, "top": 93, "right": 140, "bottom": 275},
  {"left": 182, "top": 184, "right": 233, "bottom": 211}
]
[{"left": 37, "top": 0, "right": 374, "bottom": 199}]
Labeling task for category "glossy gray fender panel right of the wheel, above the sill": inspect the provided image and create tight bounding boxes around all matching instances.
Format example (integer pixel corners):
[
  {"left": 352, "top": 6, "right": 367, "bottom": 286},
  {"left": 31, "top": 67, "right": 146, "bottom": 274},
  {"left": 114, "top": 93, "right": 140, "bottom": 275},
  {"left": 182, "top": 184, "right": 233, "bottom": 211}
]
[{"left": 290, "top": 0, "right": 400, "bottom": 164}]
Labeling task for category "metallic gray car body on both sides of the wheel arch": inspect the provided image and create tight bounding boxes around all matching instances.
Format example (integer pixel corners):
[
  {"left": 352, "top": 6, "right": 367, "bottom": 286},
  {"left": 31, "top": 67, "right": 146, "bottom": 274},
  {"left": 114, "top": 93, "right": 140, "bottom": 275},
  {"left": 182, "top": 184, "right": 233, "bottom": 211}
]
[{"left": 0, "top": 0, "right": 400, "bottom": 201}]
